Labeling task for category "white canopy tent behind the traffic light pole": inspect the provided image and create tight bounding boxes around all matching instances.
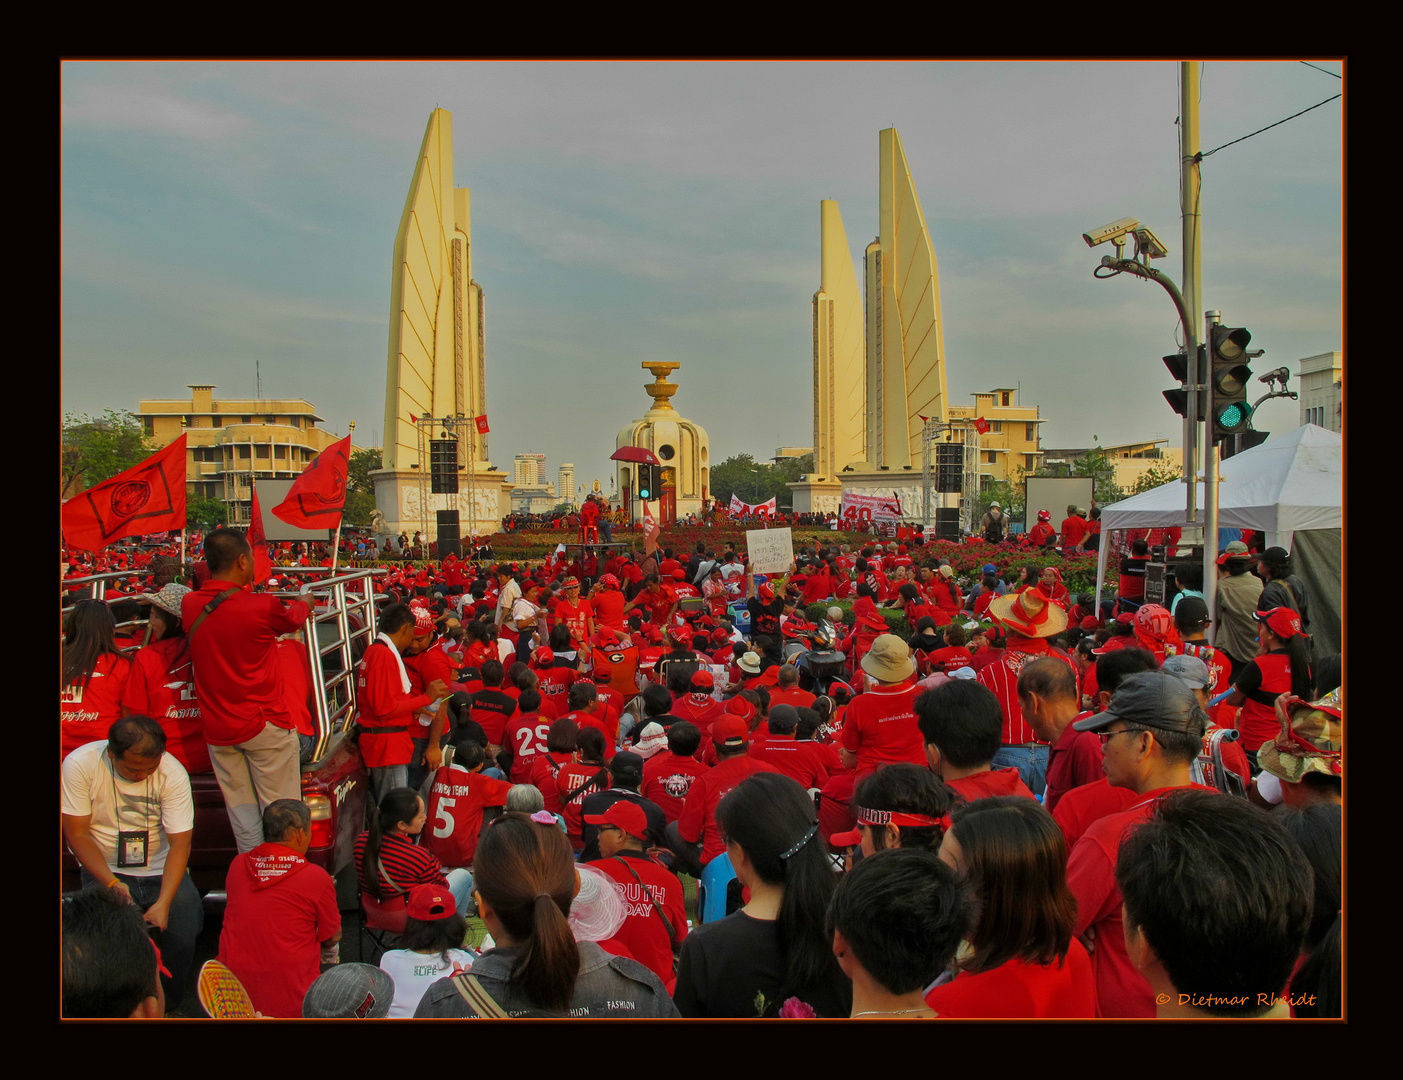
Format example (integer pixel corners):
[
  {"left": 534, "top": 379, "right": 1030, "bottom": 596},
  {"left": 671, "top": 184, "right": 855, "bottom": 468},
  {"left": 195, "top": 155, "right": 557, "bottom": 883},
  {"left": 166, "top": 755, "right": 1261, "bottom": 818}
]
[{"left": 1096, "top": 424, "right": 1344, "bottom": 644}]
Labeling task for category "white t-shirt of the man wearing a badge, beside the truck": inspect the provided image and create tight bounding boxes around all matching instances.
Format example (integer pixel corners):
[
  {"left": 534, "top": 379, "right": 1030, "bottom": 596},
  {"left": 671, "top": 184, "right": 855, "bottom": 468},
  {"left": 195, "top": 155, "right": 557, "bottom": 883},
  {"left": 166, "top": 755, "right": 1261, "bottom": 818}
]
[{"left": 60, "top": 739, "right": 195, "bottom": 884}]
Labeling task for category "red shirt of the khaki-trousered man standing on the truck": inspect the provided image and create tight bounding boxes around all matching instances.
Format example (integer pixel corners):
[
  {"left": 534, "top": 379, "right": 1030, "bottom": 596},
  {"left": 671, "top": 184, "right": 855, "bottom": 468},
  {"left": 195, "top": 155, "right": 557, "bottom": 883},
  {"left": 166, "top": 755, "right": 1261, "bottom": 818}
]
[{"left": 181, "top": 581, "right": 310, "bottom": 740}]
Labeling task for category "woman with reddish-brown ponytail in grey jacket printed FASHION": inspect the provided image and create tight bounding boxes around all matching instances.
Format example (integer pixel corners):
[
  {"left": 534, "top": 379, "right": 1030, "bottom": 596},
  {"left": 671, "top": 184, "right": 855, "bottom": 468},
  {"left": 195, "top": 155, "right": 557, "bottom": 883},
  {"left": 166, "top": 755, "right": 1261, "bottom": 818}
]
[{"left": 414, "top": 811, "right": 678, "bottom": 1018}]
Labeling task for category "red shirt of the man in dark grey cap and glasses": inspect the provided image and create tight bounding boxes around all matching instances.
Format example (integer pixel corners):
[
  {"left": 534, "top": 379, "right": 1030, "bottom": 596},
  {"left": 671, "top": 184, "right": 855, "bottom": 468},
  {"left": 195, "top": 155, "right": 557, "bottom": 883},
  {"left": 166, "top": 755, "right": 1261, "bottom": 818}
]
[{"left": 1066, "top": 784, "right": 1214, "bottom": 1018}]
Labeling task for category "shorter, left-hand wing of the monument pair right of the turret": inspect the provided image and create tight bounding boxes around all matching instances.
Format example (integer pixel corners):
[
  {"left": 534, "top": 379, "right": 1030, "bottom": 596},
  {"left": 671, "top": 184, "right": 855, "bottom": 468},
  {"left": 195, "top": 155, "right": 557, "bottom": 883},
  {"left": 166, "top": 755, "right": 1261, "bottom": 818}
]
[{"left": 814, "top": 199, "right": 867, "bottom": 477}]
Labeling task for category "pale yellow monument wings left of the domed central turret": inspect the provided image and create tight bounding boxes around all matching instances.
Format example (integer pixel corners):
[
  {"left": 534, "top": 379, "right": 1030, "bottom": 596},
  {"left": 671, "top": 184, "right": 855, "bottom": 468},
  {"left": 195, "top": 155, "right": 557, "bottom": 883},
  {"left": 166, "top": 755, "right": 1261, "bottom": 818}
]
[{"left": 384, "top": 109, "right": 487, "bottom": 470}]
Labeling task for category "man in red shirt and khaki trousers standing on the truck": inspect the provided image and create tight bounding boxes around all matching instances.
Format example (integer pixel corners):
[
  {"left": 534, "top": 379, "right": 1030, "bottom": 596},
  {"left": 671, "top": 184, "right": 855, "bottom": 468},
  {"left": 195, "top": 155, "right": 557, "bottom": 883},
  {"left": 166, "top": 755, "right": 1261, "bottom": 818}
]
[{"left": 181, "top": 529, "right": 311, "bottom": 853}]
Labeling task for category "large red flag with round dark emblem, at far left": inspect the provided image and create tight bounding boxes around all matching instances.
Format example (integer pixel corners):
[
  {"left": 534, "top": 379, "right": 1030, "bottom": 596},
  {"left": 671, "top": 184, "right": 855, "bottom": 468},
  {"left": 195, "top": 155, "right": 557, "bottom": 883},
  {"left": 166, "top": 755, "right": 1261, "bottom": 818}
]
[{"left": 60, "top": 435, "right": 185, "bottom": 551}]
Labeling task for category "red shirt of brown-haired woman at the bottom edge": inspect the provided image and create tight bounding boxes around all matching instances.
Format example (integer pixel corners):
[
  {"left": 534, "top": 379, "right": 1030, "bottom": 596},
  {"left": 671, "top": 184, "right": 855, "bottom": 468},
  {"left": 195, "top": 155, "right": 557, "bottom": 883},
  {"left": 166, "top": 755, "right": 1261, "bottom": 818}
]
[{"left": 926, "top": 937, "right": 1096, "bottom": 1020}]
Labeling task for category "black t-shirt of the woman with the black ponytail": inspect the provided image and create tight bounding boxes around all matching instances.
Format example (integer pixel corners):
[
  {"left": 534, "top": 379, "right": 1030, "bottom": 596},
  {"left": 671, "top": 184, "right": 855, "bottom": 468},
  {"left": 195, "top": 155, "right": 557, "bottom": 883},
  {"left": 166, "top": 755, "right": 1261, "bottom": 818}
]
[{"left": 672, "top": 912, "right": 853, "bottom": 1018}]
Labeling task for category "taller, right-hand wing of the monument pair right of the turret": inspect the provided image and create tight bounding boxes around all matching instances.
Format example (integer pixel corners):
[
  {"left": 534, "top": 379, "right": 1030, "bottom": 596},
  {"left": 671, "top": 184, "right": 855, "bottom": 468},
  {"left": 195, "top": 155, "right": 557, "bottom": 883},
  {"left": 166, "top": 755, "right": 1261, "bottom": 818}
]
[{"left": 867, "top": 128, "right": 947, "bottom": 468}]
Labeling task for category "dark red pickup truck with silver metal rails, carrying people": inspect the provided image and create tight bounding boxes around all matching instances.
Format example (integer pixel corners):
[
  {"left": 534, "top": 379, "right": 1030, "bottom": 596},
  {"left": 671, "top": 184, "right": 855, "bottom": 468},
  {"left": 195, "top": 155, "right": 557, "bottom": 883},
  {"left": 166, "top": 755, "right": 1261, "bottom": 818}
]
[{"left": 63, "top": 567, "right": 384, "bottom": 910}]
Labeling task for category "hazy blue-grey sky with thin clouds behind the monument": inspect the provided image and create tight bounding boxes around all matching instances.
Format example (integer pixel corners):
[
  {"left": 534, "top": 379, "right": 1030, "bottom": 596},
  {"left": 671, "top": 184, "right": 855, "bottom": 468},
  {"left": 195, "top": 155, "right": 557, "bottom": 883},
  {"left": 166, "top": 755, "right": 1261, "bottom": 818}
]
[{"left": 60, "top": 60, "right": 1344, "bottom": 491}]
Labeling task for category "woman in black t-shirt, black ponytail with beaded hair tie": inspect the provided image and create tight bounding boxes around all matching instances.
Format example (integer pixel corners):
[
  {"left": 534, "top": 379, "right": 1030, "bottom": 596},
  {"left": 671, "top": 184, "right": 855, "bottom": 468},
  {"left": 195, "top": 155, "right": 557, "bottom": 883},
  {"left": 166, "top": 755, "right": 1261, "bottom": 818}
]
[{"left": 673, "top": 773, "right": 852, "bottom": 1017}]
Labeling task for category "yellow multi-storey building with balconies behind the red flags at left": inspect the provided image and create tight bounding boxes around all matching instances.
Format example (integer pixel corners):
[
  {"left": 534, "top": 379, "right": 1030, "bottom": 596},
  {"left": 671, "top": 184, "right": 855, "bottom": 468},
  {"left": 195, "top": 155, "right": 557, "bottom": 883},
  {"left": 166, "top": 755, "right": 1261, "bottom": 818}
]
[{"left": 135, "top": 384, "right": 338, "bottom": 526}]
